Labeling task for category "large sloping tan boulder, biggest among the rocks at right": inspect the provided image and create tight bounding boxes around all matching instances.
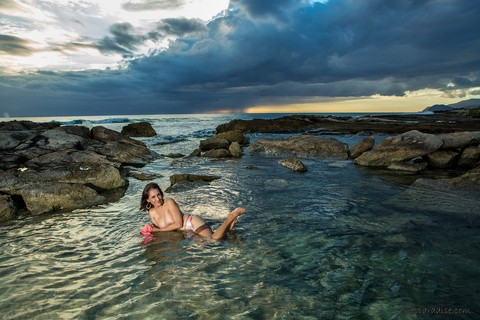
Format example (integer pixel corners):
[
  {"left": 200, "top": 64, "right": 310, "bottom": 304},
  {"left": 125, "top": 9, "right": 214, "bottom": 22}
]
[{"left": 354, "top": 130, "right": 443, "bottom": 167}]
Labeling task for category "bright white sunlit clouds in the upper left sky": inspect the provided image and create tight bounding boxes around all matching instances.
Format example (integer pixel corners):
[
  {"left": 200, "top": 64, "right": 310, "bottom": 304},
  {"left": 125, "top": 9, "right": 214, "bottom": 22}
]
[{"left": 0, "top": 0, "right": 229, "bottom": 74}]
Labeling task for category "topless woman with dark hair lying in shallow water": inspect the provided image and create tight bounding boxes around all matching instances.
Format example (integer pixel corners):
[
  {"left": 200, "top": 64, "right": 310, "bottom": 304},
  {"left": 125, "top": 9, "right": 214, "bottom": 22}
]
[{"left": 140, "top": 182, "right": 246, "bottom": 240}]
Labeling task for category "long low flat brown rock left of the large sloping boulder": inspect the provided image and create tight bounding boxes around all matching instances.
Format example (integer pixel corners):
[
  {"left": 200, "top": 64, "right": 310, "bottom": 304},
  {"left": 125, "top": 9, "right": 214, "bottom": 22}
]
[{"left": 250, "top": 135, "right": 348, "bottom": 160}]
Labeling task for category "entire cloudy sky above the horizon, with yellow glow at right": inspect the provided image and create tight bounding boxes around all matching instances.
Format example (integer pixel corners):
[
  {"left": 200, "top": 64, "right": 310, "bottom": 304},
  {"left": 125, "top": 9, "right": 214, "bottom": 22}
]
[{"left": 0, "top": 0, "right": 480, "bottom": 117}]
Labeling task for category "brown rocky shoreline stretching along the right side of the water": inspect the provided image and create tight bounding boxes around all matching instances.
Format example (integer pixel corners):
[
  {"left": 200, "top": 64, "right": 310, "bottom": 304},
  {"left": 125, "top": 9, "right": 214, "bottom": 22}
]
[{"left": 192, "top": 110, "right": 480, "bottom": 192}]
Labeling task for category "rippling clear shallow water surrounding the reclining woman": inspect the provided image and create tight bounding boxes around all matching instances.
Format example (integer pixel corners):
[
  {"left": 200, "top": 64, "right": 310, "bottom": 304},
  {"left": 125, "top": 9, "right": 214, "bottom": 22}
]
[{"left": 0, "top": 115, "right": 480, "bottom": 319}]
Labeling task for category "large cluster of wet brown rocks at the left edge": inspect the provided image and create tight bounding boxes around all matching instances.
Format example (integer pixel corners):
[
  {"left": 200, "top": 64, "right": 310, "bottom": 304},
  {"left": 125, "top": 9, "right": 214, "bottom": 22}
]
[{"left": 0, "top": 121, "right": 156, "bottom": 221}]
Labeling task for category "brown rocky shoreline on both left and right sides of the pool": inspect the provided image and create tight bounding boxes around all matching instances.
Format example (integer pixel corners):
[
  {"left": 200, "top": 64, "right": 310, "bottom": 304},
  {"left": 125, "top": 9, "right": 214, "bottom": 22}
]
[{"left": 0, "top": 111, "right": 480, "bottom": 222}]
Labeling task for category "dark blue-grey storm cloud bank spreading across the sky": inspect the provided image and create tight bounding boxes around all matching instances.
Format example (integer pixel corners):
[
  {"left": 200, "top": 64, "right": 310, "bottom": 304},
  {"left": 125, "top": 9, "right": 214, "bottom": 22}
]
[{"left": 0, "top": 0, "right": 480, "bottom": 114}]
